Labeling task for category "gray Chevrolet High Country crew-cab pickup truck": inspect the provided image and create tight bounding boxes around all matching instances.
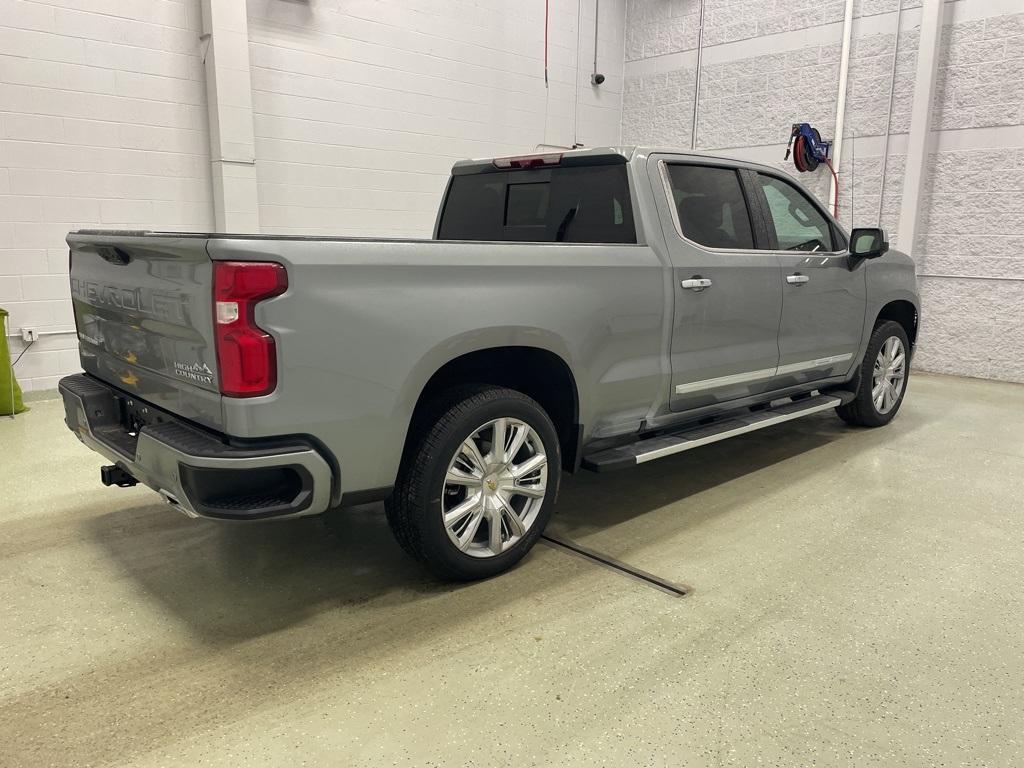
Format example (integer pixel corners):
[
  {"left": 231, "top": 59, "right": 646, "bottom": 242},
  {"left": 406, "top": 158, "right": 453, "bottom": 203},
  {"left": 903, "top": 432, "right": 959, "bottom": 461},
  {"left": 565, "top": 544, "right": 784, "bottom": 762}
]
[{"left": 60, "top": 147, "right": 919, "bottom": 579}]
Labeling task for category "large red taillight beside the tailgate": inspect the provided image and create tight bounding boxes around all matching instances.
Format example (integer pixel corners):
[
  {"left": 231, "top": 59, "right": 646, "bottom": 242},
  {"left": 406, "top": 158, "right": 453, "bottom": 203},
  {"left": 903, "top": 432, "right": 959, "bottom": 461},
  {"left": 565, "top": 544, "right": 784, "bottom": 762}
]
[{"left": 213, "top": 261, "right": 288, "bottom": 397}]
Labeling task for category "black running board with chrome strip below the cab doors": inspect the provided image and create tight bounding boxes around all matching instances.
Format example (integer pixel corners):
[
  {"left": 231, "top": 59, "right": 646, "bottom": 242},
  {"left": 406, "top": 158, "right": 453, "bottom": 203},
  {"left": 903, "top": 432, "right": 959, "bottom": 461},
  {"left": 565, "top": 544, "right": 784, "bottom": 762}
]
[{"left": 583, "top": 394, "right": 843, "bottom": 472}]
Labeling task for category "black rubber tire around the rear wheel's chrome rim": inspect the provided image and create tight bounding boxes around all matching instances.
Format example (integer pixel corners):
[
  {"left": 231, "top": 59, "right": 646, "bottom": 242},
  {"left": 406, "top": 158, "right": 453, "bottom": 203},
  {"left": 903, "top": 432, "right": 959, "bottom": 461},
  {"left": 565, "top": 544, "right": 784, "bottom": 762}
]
[{"left": 385, "top": 385, "right": 561, "bottom": 581}]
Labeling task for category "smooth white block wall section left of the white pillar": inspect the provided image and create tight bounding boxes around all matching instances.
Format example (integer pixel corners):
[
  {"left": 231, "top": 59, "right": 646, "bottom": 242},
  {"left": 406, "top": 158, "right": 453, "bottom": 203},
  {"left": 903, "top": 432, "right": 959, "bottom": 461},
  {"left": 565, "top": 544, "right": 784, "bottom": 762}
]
[{"left": 0, "top": 0, "right": 212, "bottom": 391}]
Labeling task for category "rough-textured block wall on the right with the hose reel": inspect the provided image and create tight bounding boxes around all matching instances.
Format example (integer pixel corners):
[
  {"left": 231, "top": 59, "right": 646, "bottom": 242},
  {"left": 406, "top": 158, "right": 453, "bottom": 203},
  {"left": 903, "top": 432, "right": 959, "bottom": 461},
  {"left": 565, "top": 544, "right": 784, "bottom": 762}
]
[{"left": 623, "top": 0, "right": 1024, "bottom": 381}]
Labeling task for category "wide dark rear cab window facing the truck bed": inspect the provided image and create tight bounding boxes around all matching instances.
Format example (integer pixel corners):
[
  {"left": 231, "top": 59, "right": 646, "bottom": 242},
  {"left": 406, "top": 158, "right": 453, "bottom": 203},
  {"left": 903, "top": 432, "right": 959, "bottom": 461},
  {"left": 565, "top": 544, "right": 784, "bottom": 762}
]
[{"left": 437, "top": 165, "right": 637, "bottom": 243}]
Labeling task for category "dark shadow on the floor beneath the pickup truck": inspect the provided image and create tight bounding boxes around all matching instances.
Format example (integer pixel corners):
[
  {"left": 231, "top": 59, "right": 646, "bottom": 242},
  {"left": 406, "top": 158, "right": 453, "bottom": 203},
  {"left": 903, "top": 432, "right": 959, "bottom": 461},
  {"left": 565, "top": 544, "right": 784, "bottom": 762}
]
[{"left": 82, "top": 414, "right": 910, "bottom": 646}]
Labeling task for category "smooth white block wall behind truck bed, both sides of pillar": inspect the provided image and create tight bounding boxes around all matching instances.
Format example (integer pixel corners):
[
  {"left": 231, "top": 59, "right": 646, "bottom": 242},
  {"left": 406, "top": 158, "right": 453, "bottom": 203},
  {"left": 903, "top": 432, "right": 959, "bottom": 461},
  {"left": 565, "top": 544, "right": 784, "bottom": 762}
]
[{"left": 0, "top": 0, "right": 626, "bottom": 390}]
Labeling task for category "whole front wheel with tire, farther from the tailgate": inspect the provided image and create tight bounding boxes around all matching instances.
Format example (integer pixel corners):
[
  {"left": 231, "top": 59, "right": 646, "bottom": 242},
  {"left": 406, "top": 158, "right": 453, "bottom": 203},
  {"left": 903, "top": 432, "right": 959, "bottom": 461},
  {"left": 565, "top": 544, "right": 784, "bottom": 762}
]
[{"left": 836, "top": 321, "right": 910, "bottom": 427}]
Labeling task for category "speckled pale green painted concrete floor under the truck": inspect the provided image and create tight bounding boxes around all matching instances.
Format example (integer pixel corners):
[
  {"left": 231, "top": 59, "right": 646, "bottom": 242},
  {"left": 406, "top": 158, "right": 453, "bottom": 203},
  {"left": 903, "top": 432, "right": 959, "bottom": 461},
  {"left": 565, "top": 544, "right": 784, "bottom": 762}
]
[{"left": 0, "top": 375, "right": 1024, "bottom": 767}]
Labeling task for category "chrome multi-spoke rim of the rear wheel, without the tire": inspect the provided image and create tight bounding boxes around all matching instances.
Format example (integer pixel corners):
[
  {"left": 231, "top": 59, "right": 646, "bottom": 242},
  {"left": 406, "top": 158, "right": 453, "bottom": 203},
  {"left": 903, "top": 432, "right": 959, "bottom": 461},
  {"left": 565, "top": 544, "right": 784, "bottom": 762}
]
[{"left": 441, "top": 418, "right": 548, "bottom": 557}]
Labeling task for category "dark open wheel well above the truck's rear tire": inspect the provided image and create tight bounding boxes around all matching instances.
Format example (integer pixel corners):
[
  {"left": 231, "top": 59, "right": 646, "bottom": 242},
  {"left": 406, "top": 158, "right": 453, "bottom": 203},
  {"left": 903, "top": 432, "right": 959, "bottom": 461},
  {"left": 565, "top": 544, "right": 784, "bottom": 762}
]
[{"left": 402, "top": 345, "right": 581, "bottom": 471}]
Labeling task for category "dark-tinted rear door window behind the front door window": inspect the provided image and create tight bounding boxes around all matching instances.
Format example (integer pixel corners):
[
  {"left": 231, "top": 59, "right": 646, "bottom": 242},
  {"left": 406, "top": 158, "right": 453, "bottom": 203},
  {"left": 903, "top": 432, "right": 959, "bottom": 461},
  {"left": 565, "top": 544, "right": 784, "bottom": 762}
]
[{"left": 668, "top": 165, "right": 754, "bottom": 249}]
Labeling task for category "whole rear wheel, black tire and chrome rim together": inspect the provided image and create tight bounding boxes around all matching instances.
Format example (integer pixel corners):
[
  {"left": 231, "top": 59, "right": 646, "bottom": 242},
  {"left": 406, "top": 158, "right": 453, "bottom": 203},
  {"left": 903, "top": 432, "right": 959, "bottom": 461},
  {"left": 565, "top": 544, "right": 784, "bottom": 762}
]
[{"left": 386, "top": 385, "right": 561, "bottom": 581}]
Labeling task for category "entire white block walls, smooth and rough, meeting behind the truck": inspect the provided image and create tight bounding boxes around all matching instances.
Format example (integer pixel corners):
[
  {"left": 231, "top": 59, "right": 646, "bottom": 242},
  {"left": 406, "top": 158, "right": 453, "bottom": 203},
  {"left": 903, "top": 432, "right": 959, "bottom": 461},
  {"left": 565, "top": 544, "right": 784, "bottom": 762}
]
[{"left": 0, "top": 0, "right": 1024, "bottom": 390}]
